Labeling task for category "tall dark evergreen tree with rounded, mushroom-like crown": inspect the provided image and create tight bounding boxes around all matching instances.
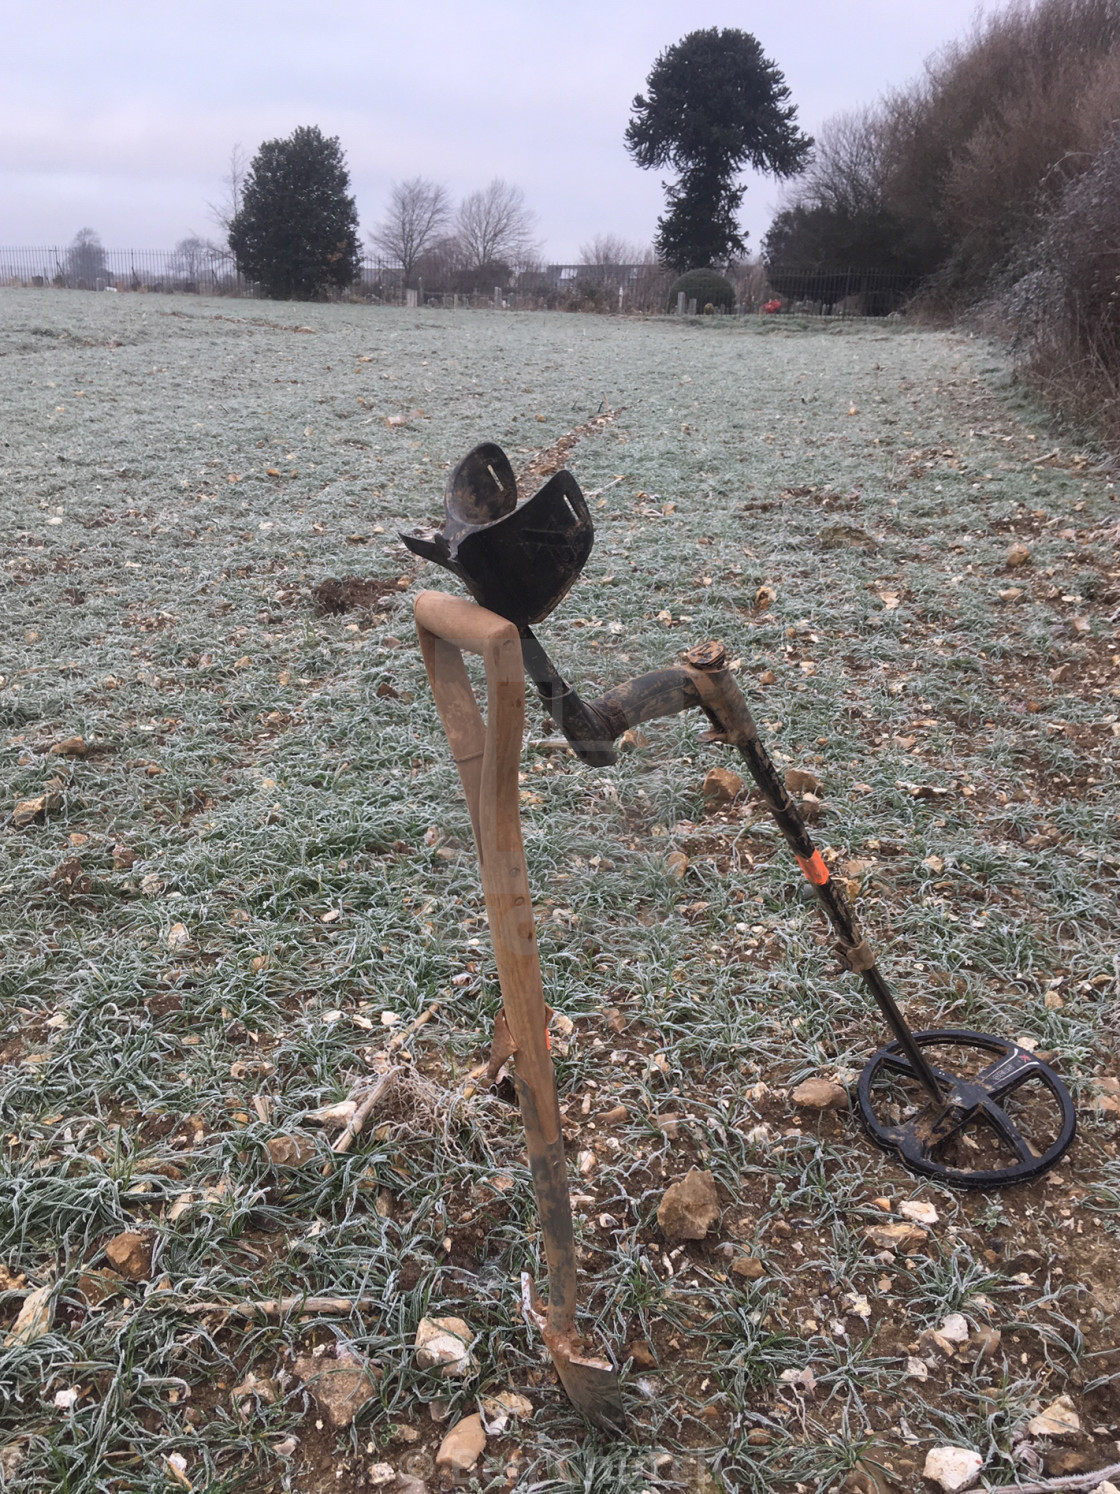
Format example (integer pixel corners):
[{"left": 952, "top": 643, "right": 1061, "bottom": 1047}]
[{"left": 626, "top": 27, "right": 812, "bottom": 270}]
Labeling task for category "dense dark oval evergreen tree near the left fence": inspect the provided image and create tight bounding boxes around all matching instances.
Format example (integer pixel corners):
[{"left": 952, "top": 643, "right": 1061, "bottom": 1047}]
[{"left": 230, "top": 125, "right": 358, "bottom": 300}]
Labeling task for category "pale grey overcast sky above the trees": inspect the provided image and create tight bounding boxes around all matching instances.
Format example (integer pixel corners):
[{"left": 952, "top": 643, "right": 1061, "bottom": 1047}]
[{"left": 0, "top": 0, "right": 1007, "bottom": 263}]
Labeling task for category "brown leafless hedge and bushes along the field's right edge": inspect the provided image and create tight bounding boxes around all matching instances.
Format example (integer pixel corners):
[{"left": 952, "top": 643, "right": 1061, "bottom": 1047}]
[{"left": 763, "top": 0, "right": 1120, "bottom": 439}]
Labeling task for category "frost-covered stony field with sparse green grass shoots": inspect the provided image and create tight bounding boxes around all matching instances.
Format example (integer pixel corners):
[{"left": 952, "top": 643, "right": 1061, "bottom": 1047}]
[{"left": 0, "top": 290, "right": 1120, "bottom": 1494}]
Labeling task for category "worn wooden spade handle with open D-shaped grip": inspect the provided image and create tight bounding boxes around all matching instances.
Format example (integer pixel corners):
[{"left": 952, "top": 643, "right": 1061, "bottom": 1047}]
[{"left": 414, "top": 592, "right": 576, "bottom": 1333}]
